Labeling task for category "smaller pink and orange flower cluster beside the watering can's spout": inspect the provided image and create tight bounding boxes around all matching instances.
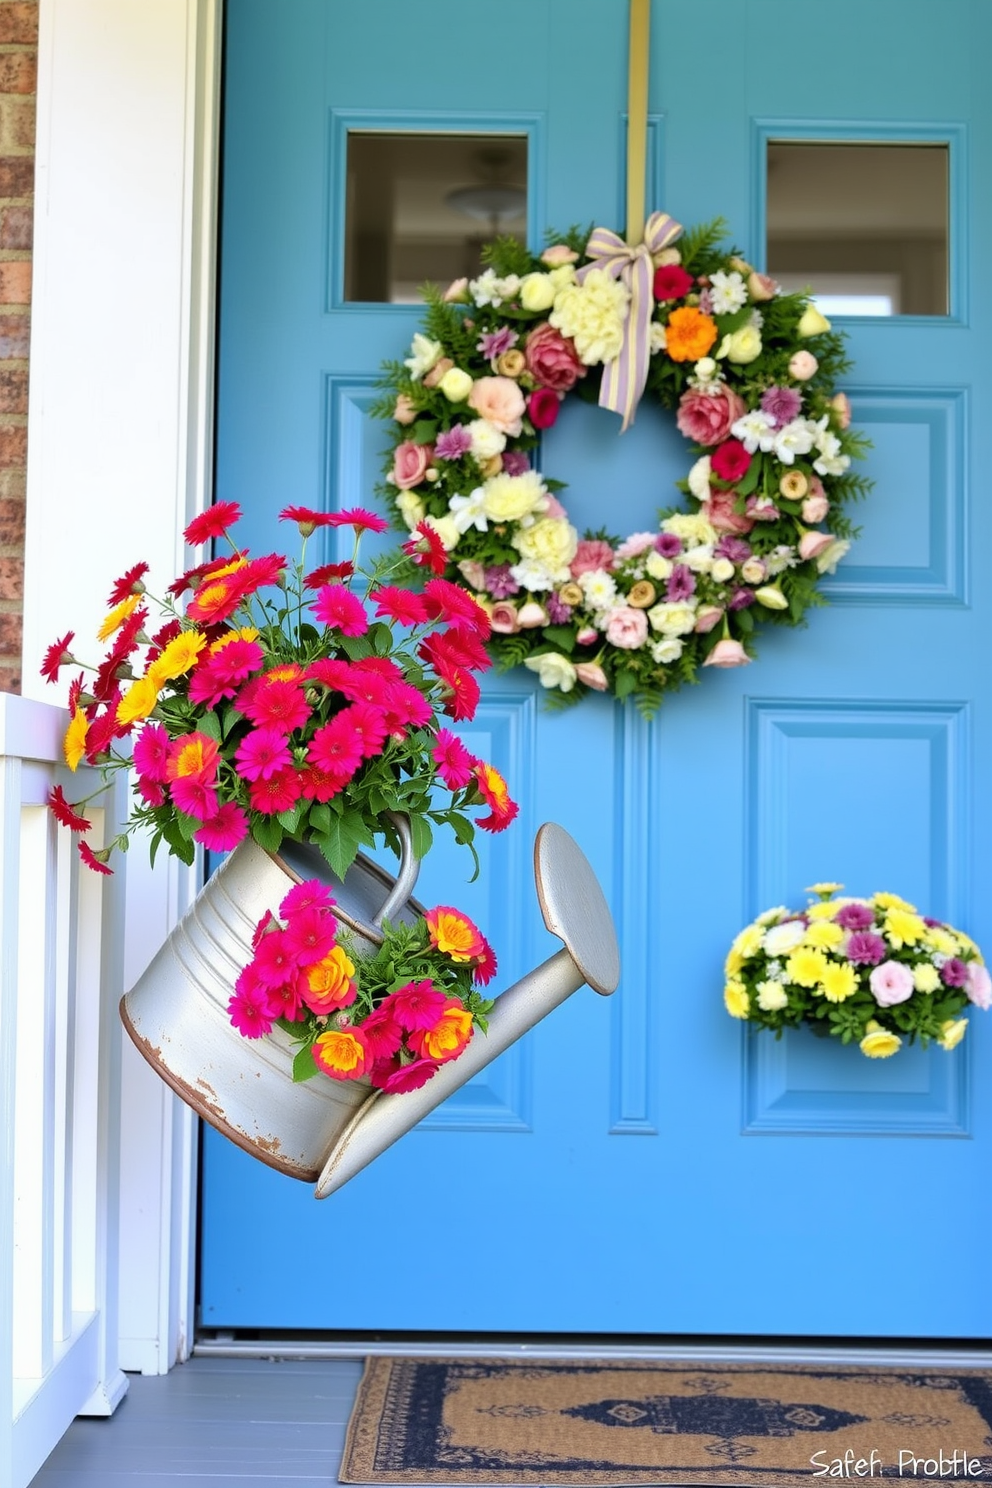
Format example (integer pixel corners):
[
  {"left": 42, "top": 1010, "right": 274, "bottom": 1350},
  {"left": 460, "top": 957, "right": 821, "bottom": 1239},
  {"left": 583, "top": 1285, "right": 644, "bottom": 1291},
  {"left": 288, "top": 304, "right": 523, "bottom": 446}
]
[{"left": 229, "top": 879, "right": 497, "bottom": 1092}]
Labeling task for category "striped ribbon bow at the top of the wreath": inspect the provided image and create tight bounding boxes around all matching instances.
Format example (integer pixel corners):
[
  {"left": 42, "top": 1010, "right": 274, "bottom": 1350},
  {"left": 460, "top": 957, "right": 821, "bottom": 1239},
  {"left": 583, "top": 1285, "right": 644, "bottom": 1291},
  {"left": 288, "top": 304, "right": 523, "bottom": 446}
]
[{"left": 577, "top": 211, "right": 683, "bottom": 433}]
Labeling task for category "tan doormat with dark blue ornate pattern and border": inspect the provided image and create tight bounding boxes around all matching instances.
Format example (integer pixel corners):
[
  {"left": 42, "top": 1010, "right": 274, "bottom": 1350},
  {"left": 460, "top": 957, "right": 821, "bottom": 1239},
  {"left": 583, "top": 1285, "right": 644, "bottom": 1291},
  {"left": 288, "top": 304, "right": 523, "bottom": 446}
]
[{"left": 339, "top": 1359, "right": 992, "bottom": 1488}]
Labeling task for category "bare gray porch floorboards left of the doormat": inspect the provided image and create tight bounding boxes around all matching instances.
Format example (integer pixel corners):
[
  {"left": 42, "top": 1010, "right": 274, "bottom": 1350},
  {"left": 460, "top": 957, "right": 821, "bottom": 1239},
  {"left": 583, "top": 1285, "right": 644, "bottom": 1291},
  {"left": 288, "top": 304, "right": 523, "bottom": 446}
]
[{"left": 31, "top": 1359, "right": 370, "bottom": 1488}]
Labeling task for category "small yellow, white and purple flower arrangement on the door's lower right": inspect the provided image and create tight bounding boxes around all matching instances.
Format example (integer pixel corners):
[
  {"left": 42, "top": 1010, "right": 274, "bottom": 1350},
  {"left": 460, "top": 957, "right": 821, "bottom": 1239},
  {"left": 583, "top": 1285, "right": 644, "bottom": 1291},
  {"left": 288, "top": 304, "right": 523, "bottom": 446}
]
[{"left": 723, "top": 884, "right": 992, "bottom": 1059}]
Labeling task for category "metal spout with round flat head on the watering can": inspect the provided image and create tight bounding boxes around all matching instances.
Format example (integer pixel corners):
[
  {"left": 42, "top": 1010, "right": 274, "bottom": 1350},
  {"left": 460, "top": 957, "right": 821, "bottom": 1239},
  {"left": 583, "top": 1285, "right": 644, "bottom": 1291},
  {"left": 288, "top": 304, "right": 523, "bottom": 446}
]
[{"left": 314, "top": 823, "right": 620, "bottom": 1199}]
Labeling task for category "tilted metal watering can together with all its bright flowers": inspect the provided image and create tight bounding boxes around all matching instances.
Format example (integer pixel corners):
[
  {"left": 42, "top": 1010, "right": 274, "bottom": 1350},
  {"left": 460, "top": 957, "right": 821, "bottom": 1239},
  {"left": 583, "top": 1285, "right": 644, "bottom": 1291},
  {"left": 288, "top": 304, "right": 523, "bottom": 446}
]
[{"left": 43, "top": 501, "right": 619, "bottom": 1198}]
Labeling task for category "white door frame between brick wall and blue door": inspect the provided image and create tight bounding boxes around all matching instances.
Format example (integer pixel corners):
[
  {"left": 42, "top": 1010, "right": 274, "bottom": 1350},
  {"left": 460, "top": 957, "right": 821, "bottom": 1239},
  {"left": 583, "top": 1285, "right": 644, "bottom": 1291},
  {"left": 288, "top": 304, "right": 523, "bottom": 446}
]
[{"left": 22, "top": 0, "right": 222, "bottom": 1373}]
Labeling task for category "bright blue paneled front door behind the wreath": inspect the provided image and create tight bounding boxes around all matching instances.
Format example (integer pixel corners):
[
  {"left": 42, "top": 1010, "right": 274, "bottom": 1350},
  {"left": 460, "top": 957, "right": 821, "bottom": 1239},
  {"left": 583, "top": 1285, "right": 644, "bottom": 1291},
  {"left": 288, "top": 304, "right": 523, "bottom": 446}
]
[{"left": 202, "top": 0, "right": 992, "bottom": 1338}]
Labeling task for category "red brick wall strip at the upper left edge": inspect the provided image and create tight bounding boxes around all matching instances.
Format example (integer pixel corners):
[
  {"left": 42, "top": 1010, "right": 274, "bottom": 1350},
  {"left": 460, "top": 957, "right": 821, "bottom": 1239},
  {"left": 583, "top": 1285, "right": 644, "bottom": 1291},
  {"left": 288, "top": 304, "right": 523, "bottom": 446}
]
[{"left": 0, "top": 0, "right": 37, "bottom": 692}]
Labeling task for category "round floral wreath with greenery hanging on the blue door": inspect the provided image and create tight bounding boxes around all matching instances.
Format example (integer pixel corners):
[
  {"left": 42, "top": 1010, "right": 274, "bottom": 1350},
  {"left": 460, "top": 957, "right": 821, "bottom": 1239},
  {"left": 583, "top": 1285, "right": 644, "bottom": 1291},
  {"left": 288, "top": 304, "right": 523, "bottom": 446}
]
[{"left": 375, "top": 213, "right": 870, "bottom": 714}]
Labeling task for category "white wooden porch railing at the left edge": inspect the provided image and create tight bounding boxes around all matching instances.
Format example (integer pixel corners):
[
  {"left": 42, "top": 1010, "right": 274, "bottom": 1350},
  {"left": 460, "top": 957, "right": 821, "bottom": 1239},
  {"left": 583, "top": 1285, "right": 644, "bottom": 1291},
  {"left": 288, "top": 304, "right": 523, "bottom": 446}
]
[{"left": 0, "top": 695, "right": 126, "bottom": 1488}]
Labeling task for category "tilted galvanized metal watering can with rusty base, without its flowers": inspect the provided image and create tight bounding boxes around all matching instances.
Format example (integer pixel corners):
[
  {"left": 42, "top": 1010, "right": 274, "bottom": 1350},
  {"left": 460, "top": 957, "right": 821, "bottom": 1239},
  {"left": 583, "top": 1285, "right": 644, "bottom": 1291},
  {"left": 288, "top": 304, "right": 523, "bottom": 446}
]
[{"left": 120, "top": 823, "right": 620, "bottom": 1199}]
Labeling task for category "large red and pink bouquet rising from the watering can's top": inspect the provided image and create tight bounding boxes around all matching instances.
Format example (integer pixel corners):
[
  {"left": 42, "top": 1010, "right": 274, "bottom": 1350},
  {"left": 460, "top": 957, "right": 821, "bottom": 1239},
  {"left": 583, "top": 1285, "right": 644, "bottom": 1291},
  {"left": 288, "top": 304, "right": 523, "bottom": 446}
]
[{"left": 42, "top": 501, "right": 518, "bottom": 879}]
